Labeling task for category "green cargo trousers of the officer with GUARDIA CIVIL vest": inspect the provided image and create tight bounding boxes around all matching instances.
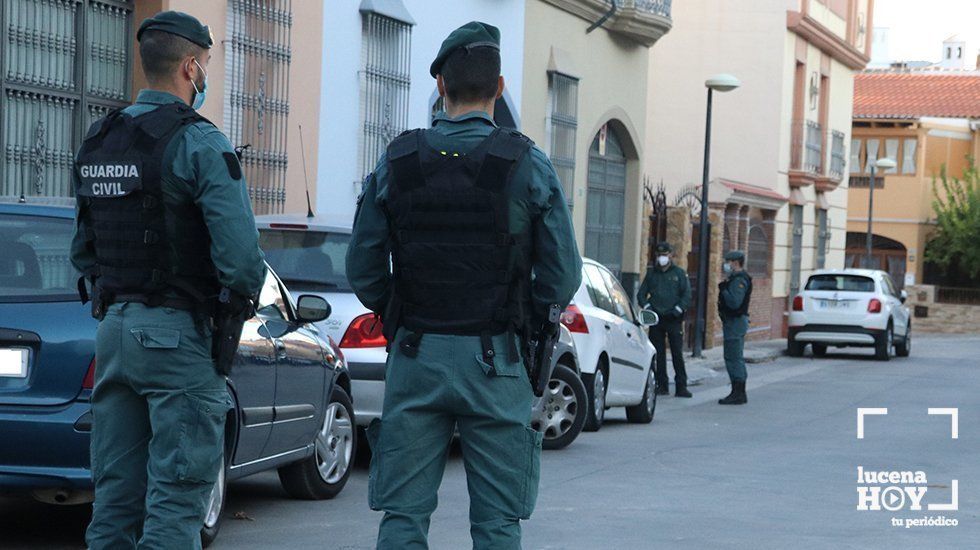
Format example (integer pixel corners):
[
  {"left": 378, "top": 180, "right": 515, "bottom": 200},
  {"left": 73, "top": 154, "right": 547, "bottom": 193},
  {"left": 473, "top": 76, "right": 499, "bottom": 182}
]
[{"left": 86, "top": 303, "right": 232, "bottom": 550}]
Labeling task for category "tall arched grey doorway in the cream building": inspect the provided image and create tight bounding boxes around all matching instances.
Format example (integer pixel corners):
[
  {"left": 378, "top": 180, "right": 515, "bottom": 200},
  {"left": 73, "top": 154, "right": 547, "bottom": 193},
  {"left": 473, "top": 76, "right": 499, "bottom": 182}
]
[{"left": 585, "top": 124, "right": 626, "bottom": 276}]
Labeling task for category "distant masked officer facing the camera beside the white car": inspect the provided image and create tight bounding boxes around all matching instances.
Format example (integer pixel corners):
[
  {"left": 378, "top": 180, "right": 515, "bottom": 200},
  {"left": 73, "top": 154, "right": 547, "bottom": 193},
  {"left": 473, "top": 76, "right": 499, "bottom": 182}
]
[{"left": 637, "top": 242, "right": 691, "bottom": 397}]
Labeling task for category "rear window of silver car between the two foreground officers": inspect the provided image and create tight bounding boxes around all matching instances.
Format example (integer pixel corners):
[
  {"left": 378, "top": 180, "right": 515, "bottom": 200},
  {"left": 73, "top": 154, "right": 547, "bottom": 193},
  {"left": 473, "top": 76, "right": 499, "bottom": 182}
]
[{"left": 259, "top": 229, "right": 351, "bottom": 292}]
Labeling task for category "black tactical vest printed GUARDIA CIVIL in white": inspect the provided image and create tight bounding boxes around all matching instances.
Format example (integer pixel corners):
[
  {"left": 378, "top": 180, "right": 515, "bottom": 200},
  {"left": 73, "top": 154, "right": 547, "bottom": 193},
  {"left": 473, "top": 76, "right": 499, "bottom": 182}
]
[{"left": 74, "top": 103, "right": 219, "bottom": 309}]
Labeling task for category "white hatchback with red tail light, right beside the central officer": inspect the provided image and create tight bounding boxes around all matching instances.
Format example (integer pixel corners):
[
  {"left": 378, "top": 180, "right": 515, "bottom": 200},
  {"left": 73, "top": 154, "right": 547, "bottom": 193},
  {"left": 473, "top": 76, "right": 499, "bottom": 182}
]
[{"left": 562, "top": 259, "right": 659, "bottom": 431}]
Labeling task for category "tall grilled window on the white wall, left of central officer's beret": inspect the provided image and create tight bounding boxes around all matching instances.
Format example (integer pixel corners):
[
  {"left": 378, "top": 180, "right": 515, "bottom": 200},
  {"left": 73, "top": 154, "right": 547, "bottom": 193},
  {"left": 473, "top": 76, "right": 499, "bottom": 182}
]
[{"left": 359, "top": 12, "right": 412, "bottom": 178}]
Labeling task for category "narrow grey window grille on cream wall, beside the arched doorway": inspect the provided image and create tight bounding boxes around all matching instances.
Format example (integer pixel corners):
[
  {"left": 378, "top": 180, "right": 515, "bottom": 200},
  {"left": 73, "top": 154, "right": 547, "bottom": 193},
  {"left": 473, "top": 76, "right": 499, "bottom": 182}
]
[{"left": 548, "top": 72, "right": 578, "bottom": 206}]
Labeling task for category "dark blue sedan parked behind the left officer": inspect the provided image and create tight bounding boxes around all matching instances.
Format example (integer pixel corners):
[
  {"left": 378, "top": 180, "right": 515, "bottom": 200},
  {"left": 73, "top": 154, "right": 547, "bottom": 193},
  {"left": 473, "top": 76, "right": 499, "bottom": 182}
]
[{"left": 0, "top": 203, "right": 356, "bottom": 543}]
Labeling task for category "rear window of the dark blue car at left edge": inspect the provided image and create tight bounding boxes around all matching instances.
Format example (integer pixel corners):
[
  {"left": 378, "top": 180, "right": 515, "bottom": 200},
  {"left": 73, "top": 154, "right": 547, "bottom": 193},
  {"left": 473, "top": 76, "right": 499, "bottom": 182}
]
[{"left": 0, "top": 214, "right": 79, "bottom": 302}]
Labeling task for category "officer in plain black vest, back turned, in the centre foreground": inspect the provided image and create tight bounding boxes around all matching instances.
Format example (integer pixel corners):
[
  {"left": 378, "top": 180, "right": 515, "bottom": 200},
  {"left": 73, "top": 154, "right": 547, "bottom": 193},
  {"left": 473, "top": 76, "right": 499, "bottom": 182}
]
[{"left": 347, "top": 22, "right": 582, "bottom": 550}]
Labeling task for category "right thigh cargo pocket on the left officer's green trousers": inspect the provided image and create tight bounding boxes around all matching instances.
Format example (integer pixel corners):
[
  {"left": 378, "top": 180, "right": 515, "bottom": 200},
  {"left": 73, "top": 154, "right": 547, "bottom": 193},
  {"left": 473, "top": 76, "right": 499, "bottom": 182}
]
[{"left": 176, "top": 389, "right": 232, "bottom": 483}]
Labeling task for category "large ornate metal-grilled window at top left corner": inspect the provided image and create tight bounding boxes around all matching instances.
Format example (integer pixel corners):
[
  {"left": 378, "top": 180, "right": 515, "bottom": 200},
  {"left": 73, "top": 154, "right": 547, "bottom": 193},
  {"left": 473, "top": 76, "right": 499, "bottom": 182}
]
[{"left": 0, "top": 0, "right": 133, "bottom": 201}]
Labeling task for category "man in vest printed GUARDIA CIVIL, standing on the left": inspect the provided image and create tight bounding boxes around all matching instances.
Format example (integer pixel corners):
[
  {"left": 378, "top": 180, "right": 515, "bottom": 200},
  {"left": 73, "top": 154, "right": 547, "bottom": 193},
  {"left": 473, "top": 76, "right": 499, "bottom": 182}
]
[{"left": 71, "top": 11, "right": 265, "bottom": 550}]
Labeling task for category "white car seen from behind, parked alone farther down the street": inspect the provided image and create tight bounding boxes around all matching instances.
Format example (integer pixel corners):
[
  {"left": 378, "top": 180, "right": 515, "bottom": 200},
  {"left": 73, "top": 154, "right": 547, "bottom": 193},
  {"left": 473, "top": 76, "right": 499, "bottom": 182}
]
[{"left": 787, "top": 269, "right": 912, "bottom": 361}]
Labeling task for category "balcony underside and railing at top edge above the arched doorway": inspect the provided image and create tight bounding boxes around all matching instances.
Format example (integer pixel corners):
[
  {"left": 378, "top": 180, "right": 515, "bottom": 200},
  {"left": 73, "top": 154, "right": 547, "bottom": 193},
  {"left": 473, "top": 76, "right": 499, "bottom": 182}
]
[{"left": 544, "top": 0, "right": 673, "bottom": 47}]
